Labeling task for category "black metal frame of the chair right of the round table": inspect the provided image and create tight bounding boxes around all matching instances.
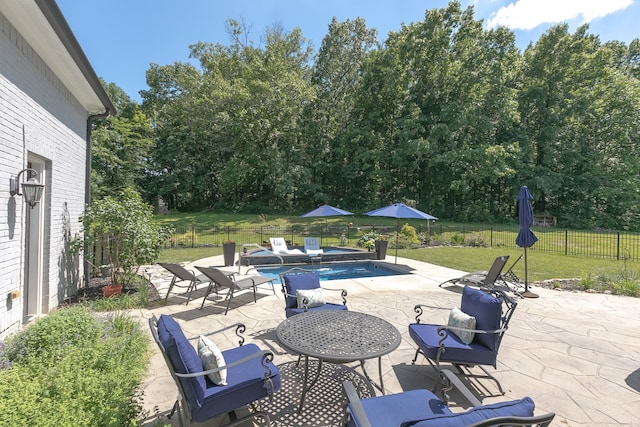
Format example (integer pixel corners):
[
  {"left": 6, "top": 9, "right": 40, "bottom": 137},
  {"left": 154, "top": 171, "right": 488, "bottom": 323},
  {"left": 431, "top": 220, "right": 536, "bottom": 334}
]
[{"left": 411, "top": 289, "right": 518, "bottom": 402}]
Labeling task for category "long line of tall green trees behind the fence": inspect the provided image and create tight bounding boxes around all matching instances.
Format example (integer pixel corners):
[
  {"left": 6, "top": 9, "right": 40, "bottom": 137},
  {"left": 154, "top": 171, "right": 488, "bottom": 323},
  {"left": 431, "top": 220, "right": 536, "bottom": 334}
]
[{"left": 92, "top": 1, "right": 640, "bottom": 230}]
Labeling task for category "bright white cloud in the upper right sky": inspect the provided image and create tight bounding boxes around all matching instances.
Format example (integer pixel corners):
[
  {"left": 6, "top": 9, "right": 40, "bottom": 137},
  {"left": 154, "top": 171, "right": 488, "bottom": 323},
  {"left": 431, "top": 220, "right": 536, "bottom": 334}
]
[{"left": 487, "top": 0, "right": 633, "bottom": 30}]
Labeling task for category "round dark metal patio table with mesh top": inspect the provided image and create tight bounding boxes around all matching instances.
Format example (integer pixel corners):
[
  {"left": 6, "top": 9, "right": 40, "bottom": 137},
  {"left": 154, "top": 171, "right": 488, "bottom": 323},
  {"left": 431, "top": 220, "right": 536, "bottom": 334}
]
[{"left": 276, "top": 310, "right": 400, "bottom": 412}]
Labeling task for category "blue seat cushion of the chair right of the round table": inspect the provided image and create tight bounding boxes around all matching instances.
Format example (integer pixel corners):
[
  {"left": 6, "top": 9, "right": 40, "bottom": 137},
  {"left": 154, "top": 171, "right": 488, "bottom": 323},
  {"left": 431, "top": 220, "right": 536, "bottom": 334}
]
[{"left": 409, "top": 323, "right": 497, "bottom": 365}]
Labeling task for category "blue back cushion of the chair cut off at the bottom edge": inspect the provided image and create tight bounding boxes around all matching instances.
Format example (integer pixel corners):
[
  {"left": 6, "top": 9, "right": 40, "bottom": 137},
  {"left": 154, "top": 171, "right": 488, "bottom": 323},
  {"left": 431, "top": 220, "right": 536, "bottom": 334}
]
[{"left": 404, "top": 397, "right": 535, "bottom": 427}]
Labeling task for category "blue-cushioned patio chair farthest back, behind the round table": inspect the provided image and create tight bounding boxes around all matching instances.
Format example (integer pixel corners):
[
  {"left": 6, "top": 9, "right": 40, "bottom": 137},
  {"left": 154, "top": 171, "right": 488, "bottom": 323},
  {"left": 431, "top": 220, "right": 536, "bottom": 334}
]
[{"left": 280, "top": 267, "right": 347, "bottom": 317}]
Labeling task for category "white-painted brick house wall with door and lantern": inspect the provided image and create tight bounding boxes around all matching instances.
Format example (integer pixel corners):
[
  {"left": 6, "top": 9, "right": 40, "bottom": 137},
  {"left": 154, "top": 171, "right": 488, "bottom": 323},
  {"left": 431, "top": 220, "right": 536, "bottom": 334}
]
[{"left": 0, "top": 10, "right": 88, "bottom": 338}]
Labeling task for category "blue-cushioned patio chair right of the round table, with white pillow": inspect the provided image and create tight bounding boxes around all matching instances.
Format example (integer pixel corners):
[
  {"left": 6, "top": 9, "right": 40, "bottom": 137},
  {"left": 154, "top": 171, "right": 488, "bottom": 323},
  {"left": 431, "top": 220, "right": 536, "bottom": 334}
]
[{"left": 409, "top": 286, "right": 517, "bottom": 395}]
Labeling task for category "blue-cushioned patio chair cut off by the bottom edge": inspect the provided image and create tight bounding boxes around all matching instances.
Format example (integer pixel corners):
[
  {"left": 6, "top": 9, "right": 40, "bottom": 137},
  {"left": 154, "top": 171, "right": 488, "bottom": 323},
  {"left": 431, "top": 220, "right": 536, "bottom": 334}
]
[{"left": 343, "top": 381, "right": 555, "bottom": 427}]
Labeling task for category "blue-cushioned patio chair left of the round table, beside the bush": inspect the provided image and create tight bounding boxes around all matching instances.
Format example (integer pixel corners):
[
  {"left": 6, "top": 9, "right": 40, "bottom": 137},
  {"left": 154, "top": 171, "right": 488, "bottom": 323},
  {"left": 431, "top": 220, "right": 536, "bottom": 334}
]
[{"left": 149, "top": 314, "right": 280, "bottom": 426}]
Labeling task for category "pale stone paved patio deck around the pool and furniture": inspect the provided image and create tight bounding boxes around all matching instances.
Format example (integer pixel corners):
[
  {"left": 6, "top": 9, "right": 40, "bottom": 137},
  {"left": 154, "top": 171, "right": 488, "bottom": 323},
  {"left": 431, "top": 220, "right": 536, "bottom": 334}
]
[{"left": 136, "top": 256, "right": 640, "bottom": 427}]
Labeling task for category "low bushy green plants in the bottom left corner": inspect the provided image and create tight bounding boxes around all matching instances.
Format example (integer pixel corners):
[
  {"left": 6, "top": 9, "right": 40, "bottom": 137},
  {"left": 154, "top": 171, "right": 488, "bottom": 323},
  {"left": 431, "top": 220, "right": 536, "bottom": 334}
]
[{"left": 0, "top": 307, "right": 150, "bottom": 426}]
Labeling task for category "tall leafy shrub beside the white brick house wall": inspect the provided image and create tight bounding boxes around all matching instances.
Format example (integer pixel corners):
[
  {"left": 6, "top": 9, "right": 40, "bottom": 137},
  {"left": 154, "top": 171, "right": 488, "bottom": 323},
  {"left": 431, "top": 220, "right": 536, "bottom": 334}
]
[{"left": 80, "top": 189, "right": 170, "bottom": 296}]
